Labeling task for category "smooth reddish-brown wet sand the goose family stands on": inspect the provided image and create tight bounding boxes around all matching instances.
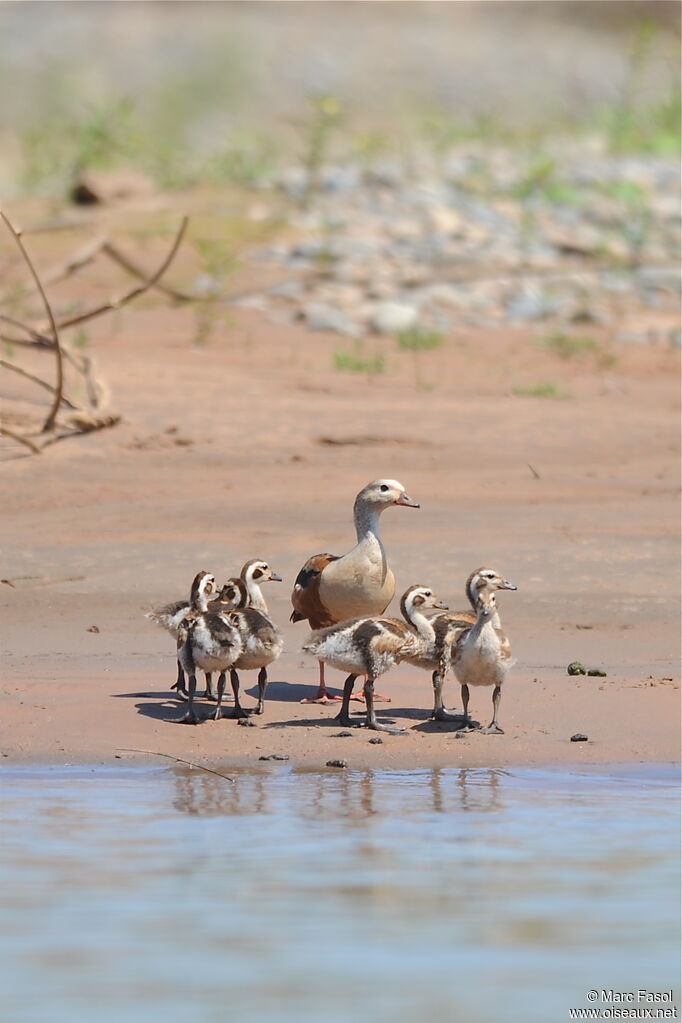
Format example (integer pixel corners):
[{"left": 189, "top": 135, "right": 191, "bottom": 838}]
[{"left": 0, "top": 280, "right": 680, "bottom": 768}]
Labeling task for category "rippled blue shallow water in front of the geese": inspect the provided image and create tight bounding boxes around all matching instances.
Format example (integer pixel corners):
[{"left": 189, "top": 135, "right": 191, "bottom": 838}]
[{"left": 0, "top": 765, "right": 679, "bottom": 1023}]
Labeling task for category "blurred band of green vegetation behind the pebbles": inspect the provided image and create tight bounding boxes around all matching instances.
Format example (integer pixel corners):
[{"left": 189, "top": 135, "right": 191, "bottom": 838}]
[{"left": 0, "top": 17, "right": 682, "bottom": 201}]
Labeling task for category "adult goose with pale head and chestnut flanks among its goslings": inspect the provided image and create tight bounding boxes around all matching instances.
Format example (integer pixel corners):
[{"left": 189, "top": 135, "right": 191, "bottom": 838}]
[{"left": 290, "top": 480, "right": 419, "bottom": 704}]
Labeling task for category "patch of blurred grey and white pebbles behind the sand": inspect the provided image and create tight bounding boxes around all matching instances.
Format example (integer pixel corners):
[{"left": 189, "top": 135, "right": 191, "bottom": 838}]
[{"left": 233, "top": 139, "right": 680, "bottom": 333}]
